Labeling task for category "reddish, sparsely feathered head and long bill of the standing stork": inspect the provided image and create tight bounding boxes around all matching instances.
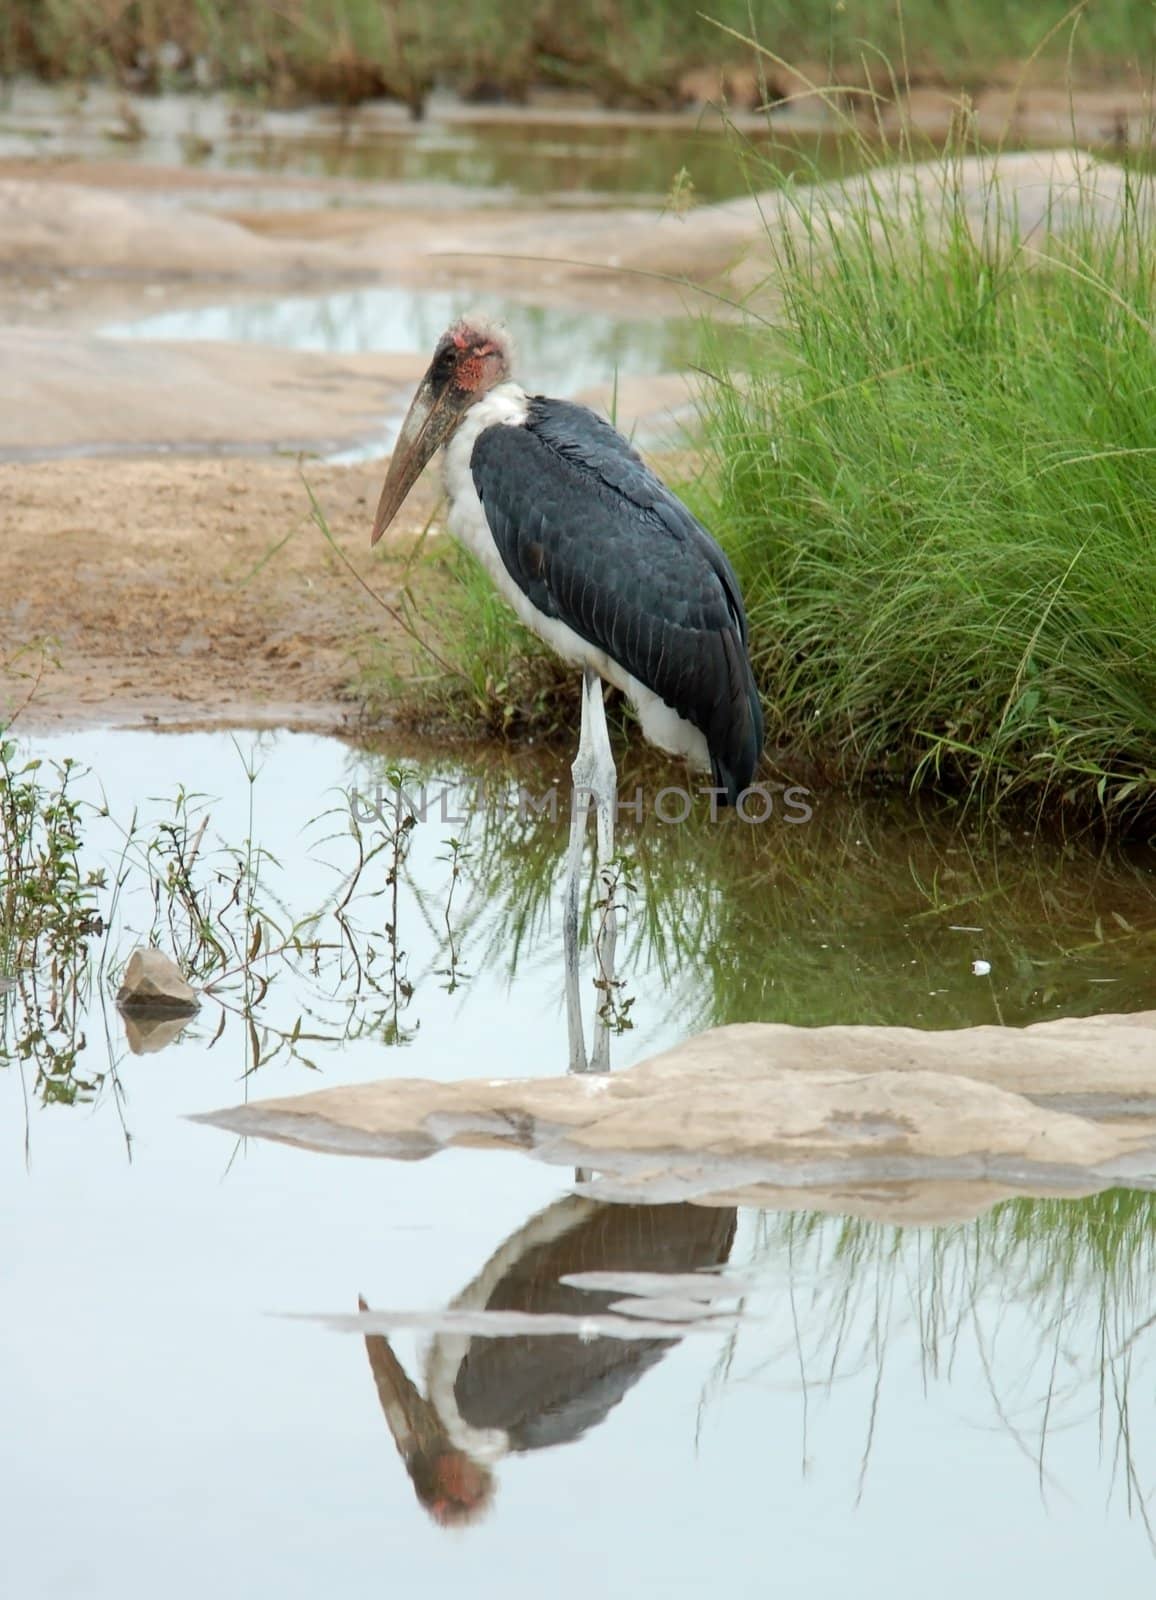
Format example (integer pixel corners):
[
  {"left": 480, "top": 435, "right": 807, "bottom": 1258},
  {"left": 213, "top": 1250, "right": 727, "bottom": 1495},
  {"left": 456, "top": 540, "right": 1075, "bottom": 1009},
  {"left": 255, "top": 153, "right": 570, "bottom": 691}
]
[{"left": 370, "top": 315, "right": 511, "bottom": 544}]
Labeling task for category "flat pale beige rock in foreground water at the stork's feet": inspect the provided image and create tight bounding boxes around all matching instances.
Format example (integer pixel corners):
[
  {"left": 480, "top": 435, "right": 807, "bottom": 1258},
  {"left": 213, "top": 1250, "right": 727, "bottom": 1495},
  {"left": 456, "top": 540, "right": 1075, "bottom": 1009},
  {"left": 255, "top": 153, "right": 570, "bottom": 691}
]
[{"left": 202, "top": 1013, "right": 1156, "bottom": 1211}]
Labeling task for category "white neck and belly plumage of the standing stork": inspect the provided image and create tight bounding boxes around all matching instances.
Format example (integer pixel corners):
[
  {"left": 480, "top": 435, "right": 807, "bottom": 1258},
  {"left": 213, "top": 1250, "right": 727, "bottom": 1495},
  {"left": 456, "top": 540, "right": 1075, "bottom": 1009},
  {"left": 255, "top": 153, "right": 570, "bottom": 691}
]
[{"left": 444, "top": 384, "right": 711, "bottom": 770}]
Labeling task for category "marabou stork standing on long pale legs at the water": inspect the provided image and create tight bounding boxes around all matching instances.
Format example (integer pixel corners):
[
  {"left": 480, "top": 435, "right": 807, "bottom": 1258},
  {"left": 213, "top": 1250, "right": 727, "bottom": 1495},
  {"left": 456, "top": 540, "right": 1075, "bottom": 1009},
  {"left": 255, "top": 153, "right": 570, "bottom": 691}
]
[{"left": 371, "top": 315, "right": 764, "bottom": 1067}]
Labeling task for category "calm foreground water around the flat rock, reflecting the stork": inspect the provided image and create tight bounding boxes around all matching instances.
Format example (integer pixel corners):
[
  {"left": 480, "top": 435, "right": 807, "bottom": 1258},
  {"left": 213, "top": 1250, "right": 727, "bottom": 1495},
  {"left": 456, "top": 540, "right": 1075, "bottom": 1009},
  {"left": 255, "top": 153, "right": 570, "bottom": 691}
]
[{"left": 0, "top": 733, "right": 1156, "bottom": 1600}]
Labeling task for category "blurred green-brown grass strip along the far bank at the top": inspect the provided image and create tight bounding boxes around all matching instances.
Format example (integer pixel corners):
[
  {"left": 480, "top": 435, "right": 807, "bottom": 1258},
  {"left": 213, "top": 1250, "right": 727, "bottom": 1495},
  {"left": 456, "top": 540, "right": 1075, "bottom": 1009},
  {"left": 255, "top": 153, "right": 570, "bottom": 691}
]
[{"left": 9, "top": 0, "right": 1153, "bottom": 115}]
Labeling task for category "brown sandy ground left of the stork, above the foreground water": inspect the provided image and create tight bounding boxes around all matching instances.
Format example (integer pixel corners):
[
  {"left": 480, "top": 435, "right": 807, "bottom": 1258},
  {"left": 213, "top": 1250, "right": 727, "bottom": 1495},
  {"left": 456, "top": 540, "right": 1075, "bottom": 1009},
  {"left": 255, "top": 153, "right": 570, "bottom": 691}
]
[{"left": 0, "top": 459, "right": 431, "bottom": 731}]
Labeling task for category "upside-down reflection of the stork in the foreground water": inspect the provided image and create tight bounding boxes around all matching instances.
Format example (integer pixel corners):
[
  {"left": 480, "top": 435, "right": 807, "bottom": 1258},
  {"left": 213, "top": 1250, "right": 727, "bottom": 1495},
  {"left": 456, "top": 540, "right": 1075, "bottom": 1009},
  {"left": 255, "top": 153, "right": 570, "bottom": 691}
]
[{"left": 360, "top": 1195, "right": 737, "bottom": 1526}]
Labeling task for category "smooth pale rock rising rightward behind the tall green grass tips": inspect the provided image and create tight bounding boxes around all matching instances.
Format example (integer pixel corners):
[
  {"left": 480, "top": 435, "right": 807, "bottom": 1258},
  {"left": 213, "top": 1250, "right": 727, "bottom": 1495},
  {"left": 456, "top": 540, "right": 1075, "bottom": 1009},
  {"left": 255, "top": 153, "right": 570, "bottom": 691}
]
[{"left": 330, "top": 149, "right": 1154, "bottom": 307}]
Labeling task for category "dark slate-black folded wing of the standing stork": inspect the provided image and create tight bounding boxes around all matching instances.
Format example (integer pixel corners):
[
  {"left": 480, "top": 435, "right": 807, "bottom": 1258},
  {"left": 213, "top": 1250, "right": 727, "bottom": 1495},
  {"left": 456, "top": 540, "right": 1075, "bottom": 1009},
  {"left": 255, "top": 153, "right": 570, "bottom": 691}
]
[{"left": 471, "top": 395, "right": 762, "bottom": 803}]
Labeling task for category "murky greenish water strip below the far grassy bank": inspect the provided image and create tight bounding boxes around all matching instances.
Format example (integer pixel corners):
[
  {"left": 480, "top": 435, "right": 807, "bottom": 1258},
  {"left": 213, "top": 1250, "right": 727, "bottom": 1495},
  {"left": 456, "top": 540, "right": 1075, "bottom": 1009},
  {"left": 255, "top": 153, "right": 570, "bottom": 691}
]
[{"left": 0, "top": 85, "right": 849, "bottom": 206}]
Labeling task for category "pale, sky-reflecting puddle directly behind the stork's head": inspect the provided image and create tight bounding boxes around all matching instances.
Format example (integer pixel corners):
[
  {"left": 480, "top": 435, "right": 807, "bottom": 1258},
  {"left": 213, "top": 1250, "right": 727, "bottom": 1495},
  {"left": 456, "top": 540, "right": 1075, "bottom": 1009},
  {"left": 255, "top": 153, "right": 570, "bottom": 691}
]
[{"left": 101, "top": 288, "right": 696, "bottom": 461}]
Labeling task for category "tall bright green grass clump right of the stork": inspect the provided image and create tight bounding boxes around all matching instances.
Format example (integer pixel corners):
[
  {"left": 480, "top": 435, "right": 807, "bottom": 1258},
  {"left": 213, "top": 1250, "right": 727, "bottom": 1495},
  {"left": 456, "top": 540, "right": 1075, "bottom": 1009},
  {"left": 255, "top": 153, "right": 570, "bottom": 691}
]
[{"left": 704, "top": 136, "right": 1156, "bottom": 822}]
